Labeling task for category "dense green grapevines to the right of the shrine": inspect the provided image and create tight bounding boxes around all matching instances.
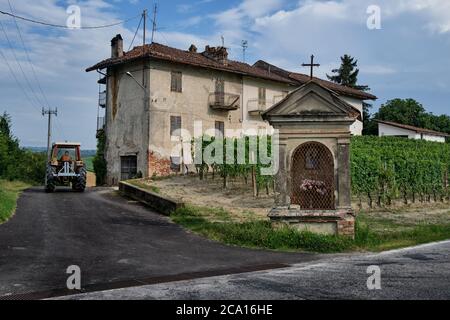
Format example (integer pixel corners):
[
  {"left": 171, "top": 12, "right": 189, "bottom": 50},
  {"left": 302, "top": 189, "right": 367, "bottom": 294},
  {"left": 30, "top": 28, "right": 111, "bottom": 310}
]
[{"left": 351, "top": 137, "right": 450, "bottom": 207}]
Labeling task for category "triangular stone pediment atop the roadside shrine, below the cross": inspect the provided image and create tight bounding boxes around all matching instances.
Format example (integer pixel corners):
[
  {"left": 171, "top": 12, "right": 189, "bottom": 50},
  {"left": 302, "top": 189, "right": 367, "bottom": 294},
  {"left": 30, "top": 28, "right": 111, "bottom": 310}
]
[{"left": 262, "top": 81, "right": 361, "bottom": 121}]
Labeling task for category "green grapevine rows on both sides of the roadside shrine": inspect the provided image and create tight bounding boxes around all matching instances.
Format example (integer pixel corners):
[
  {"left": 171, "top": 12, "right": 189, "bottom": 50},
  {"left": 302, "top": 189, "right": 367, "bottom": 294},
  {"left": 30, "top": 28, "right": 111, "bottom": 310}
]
[{"left": 193, "top": 137, "right": 450, "bottom": 207}]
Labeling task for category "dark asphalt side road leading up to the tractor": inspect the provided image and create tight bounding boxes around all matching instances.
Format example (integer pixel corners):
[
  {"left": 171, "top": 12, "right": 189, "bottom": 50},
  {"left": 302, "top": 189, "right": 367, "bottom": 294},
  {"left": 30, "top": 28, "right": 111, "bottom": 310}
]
[{"left": 0, "top": 188, "right": 319, "bottom": 298}]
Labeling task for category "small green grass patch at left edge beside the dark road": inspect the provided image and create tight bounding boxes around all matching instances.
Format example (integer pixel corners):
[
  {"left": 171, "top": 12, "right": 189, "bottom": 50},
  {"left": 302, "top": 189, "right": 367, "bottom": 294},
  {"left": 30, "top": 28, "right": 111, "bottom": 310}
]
[{"left": 0, "top": 180, "right": 29, "bottom": 223}]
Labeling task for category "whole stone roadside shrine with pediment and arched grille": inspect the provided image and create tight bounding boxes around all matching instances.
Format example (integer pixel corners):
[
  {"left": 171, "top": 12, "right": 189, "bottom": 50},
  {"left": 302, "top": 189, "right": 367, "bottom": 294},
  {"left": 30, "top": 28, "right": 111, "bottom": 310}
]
[{"left": 262, "top": 80, "right": 361, "bottom": 236}]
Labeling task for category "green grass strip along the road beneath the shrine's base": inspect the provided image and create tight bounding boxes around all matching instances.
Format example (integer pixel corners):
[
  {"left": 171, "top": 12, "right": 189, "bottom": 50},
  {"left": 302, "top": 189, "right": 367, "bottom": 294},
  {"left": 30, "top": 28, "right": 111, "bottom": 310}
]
[{"left": 171, "top": 206, "right": 450, "bottom": 253}]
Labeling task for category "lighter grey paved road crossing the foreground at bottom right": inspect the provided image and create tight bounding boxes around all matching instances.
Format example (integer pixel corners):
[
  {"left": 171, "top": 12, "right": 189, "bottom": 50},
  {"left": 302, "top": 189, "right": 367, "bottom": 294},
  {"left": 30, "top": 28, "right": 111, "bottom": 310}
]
[{"left": 59, "top": 241, "right": 450, "bottom": 300}]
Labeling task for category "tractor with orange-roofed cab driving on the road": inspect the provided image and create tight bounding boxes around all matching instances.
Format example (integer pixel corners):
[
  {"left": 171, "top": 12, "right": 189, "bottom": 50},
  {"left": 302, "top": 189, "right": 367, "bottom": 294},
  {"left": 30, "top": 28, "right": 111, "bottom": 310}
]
[{"left": 45, "top": 142, "right": 86, "bottom": 192}]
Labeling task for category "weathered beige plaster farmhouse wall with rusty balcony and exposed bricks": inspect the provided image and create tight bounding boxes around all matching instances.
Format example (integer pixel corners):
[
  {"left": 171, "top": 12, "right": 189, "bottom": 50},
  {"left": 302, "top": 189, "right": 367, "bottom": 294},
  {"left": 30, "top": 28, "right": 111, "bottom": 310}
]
[{"left": 149, "top": 61, "right": 242, "bottom": 176}]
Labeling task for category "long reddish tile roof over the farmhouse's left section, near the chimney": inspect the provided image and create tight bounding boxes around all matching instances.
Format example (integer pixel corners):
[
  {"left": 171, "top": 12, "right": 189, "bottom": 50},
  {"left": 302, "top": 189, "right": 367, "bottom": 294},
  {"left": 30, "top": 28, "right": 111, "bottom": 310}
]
[{"left": 86, "top": 43, "right": 296, "bottom": 85}]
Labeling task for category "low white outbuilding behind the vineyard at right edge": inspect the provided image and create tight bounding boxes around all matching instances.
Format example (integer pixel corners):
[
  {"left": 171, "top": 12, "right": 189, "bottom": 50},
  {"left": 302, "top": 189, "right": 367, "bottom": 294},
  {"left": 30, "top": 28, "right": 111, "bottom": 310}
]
[{"left": 377, "top": 120, "right": 450, "bottom": 143}]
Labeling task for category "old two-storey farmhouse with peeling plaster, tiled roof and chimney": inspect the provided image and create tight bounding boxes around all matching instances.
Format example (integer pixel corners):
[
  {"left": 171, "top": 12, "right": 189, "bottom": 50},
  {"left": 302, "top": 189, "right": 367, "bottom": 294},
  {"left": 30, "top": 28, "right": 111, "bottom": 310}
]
[{"left": 86, "top": 35, "right": 376, "bottom": 185}]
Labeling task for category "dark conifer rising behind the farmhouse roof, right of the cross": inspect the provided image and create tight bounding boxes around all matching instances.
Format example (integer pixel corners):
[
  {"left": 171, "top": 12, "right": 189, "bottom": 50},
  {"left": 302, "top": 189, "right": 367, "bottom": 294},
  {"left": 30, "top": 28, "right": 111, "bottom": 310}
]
[{"left": 327, "top": 54, "right": 370, "bottom": 91}]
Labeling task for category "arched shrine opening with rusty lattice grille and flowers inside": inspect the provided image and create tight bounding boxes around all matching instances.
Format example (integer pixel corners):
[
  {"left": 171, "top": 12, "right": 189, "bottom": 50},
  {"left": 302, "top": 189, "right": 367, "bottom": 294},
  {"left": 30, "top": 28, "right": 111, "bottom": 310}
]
[{"left": 291, "top": 142, "right": 335, "bottom": 210}]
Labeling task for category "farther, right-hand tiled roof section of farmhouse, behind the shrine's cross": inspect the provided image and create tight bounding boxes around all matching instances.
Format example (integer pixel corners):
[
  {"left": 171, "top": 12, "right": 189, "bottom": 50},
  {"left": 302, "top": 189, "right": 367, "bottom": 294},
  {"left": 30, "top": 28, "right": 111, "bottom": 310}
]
[{"left": 253, "top": 60, "right": 377, "bottom": 100}]
